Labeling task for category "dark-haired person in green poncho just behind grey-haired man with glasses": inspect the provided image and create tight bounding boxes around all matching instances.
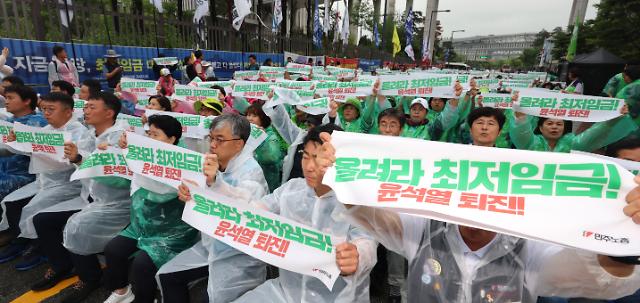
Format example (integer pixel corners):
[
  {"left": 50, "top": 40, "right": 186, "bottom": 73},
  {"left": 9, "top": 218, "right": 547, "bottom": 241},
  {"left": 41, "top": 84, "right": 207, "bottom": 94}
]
[{"left": 247, "top": 102, "right": 289, "bottom": 192}]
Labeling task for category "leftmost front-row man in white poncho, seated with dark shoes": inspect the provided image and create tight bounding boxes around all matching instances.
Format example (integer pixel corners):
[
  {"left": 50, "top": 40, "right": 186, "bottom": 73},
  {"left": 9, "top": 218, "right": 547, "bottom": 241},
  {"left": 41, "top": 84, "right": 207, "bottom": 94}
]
[{"left": 0, "top": 93, "right": 93, "bottom": 270}]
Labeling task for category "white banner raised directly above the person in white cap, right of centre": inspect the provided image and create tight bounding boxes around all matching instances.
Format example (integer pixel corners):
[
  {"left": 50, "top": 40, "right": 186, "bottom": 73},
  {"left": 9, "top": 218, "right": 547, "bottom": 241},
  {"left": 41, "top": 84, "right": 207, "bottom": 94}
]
[{"left": 380, "top": 75, "right": 456, "bottom": 98}]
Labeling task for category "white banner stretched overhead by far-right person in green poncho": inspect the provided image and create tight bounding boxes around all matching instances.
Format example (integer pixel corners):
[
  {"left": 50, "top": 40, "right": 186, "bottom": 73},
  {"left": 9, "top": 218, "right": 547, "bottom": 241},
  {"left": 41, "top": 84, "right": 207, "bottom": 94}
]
[{"left": 513, "top": 89, "right": 624, "bottom": 122}]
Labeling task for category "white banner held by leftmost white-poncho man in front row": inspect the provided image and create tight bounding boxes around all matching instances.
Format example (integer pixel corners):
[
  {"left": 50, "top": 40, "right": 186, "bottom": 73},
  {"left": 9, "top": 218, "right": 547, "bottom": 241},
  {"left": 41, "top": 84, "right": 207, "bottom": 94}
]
[{"left": 7, "top": 122, "right": 71, "bottom": 162}]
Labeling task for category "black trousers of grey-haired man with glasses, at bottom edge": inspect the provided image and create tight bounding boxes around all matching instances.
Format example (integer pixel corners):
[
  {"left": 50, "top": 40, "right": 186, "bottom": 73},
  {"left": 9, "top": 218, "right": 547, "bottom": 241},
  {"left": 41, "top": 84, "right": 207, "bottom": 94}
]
[{"left": 159, "top": 266, "right": 209, "bottom": 303}]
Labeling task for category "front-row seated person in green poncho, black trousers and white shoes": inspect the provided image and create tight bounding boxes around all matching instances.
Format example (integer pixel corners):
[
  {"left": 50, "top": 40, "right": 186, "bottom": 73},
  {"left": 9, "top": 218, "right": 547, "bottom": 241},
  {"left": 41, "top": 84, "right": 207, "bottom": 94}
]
[{"left": 104, "top": 115, "right": 200, "bottom": 302}]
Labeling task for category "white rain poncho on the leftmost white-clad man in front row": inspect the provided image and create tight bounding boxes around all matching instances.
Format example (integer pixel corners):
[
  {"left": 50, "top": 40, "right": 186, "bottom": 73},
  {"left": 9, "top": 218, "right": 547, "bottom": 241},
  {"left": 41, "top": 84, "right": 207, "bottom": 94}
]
[{"left": 0, "top": 119, "right": 95, "bottom": 239}]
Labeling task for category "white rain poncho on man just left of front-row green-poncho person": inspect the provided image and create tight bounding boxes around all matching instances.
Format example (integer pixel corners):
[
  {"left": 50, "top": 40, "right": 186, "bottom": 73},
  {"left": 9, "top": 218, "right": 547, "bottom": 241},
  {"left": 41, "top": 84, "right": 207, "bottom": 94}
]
[{"left": 63, "top": 124, "right": 131, "bottom": 255}]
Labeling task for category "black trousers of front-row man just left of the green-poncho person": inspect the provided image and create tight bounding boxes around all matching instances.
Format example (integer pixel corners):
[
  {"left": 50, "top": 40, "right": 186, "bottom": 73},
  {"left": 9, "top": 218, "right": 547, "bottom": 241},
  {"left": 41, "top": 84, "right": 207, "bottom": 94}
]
[{"left": 33, "top": 210, "right": 102, "bottom": 283}]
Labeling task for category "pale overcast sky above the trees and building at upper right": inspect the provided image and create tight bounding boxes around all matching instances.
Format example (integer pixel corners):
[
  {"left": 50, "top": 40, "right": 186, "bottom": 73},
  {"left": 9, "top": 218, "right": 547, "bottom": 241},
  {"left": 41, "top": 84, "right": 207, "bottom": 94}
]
[{"left": 396, "top": 0, "right": 600, "bottom": 39}]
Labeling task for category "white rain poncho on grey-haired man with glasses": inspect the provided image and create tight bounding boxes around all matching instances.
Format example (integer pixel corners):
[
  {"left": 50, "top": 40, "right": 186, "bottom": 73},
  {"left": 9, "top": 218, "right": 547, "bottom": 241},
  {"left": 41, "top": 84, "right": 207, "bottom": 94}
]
[{"left": 161, "top": 147, "right": 269, "bottom": 302}]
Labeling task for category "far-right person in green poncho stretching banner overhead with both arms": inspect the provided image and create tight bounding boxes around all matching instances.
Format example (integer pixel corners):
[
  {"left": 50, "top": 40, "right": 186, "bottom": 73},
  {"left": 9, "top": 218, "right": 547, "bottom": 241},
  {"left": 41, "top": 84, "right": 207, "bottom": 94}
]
[{"left": 509, "top": 106, "right": 637, "bottom": 153}]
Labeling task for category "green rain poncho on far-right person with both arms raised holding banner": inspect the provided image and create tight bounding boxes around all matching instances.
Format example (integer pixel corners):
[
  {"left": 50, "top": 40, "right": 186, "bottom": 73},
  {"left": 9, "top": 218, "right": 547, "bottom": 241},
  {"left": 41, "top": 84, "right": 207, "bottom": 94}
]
[{"left": 509, "top": 115, "right": 637, "bottom": 153}]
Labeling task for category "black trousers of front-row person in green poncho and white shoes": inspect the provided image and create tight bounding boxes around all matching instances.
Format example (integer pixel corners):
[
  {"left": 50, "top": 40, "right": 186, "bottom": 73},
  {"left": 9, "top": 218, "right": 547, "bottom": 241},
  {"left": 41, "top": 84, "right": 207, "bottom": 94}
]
[{"left": 104, "top": 236, "right": 158, "bottom": 303}]
